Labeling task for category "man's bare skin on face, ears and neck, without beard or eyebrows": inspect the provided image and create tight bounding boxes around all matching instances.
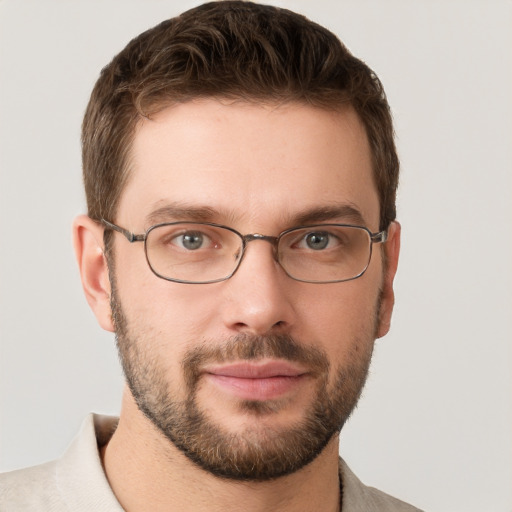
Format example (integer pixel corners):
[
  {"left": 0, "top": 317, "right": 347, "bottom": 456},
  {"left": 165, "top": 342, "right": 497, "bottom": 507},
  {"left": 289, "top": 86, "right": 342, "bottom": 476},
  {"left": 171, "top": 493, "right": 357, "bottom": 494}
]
[{"left": 74, "top": 99, "right": 400, "bottom": 512}]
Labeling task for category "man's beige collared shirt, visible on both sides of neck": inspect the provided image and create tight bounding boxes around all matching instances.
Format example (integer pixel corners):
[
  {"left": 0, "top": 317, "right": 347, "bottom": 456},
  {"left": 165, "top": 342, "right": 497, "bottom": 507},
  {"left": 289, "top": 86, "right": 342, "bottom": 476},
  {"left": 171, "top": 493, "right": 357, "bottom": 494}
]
[{"left": 0, "top": 414, "right": 420, "bottom": 512}]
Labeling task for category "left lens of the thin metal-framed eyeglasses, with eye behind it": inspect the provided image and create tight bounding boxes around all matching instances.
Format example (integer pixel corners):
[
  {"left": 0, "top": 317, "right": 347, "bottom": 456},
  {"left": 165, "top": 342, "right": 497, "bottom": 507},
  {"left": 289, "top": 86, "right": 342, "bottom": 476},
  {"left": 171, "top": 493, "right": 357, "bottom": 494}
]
[{"left": 146, "top": 222, "right": 242, "bottom": 283}]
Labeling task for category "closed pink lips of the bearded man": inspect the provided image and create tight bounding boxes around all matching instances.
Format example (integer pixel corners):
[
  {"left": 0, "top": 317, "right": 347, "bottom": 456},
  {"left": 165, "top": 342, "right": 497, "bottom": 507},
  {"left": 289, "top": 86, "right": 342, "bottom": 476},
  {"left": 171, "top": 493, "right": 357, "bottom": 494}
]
[{"left": 203, "top": 360, "right": 309, "bottom": 401}]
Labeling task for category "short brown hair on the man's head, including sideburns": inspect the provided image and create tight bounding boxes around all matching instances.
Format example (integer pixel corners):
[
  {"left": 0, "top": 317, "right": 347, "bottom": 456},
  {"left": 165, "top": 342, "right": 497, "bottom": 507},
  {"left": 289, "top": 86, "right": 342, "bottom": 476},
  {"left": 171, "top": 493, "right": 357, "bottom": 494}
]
[{"left": 82, "top": 1, "right": 399, "bottom": 229}]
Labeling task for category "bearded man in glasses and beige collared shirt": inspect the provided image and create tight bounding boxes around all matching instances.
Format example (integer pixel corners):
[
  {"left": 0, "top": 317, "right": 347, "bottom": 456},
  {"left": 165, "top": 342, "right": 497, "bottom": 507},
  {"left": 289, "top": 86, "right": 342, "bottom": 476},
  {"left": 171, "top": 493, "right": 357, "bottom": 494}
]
[{"left": 0, "top": 1, "right": 422, "bottom": 512}]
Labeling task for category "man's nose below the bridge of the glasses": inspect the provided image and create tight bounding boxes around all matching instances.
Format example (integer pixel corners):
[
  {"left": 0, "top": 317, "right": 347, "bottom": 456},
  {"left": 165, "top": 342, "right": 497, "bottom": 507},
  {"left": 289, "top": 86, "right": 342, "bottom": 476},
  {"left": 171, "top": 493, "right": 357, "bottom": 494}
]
[{"left": 222, "top": 239, "right": 297, "bottom": 335}]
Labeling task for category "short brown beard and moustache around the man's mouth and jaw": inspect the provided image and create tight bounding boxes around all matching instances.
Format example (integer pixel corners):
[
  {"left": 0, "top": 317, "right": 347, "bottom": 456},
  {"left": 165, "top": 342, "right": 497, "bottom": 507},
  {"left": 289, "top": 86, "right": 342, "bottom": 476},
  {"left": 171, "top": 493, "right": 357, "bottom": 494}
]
[{"left": 111, "top": 280, "right": 378, "bottom": 482}]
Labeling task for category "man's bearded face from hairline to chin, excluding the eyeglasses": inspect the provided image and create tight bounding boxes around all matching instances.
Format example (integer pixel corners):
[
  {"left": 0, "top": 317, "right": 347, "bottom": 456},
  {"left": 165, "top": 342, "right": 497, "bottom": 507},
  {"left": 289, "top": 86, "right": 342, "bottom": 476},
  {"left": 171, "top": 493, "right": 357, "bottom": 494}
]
[{"left": 107, "top": 100, "right": 396, "bottom": 480}]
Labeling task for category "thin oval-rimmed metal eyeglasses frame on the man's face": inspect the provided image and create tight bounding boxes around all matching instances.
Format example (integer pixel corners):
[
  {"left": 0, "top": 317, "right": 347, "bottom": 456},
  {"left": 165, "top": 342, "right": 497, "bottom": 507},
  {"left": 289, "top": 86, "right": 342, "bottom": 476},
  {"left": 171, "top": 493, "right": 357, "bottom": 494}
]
[{"left": 100, "top": 219, "right": 388, "bottom": 284}]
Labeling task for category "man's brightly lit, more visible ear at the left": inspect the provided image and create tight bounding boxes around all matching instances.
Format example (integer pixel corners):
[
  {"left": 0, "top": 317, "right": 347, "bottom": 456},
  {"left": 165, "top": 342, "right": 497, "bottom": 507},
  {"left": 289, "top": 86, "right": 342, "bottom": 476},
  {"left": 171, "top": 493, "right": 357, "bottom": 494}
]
[{"left": 73, "top": 215, "right": 114, "bottom": 332}]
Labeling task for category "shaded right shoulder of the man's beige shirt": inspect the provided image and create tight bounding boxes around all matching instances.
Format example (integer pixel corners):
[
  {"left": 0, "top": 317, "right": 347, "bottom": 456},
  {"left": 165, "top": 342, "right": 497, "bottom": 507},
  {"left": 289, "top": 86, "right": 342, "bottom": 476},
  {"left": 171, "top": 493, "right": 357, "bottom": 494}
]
[{"left": 340, "top": 459, "right": 421, "bottom": 512}]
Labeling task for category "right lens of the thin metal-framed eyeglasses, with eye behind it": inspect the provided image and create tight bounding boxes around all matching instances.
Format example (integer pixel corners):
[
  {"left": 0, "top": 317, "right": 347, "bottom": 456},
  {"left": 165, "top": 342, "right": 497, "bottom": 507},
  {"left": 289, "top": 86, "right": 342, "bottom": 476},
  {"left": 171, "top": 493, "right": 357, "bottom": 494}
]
[{"left": 278, "top": 224, "right": 371, "bottom": 283}]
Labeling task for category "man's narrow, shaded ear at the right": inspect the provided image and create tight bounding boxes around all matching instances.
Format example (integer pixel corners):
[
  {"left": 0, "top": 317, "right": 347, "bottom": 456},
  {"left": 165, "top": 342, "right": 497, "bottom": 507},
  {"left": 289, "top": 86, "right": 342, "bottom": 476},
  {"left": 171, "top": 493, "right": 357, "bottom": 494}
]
[{"left": 377, "top": 221, "right": 401, "bottom": 338}]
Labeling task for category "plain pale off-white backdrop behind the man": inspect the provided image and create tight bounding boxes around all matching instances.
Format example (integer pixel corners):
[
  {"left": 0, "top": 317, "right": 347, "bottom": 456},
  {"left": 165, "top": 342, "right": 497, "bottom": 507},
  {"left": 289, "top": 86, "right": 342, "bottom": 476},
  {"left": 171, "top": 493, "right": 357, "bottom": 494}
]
[{"left": 0, "top": 0, "right": 512, "bottom": 512}]
